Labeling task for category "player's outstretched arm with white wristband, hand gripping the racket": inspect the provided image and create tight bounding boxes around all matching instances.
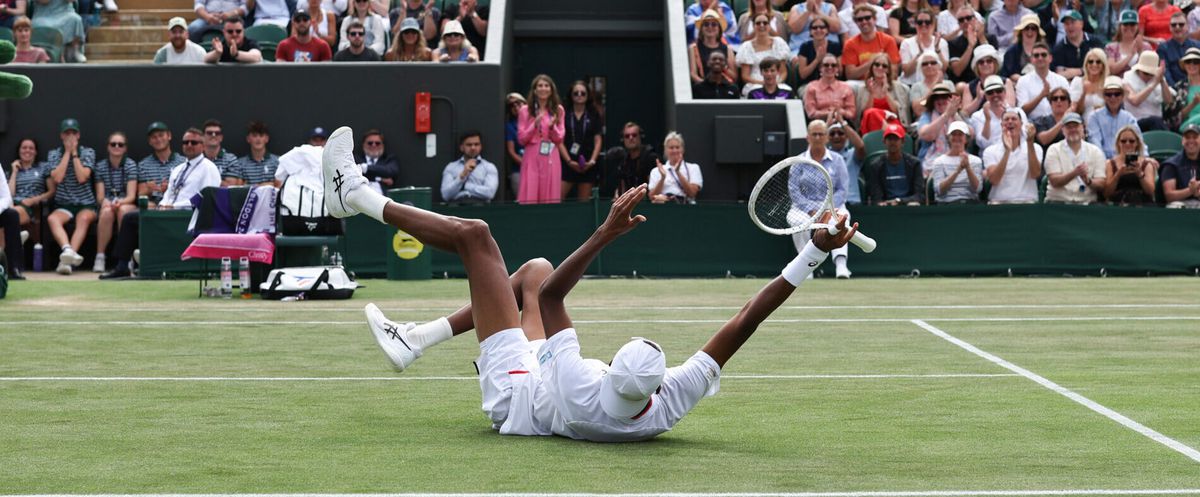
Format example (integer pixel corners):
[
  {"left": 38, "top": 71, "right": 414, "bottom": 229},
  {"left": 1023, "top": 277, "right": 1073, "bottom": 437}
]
[{"left": 701, "top": 211, "right": 858, "bottom": 367}]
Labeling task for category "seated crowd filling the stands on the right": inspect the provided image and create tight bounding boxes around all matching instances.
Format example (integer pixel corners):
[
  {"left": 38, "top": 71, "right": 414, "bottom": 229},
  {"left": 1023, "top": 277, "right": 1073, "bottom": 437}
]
[{"left": 685, "top": 0, "right": 1200, "bottom": 208}]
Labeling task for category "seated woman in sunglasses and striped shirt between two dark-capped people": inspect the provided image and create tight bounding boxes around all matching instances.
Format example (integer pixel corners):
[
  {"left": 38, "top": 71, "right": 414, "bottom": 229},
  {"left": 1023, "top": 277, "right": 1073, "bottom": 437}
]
[{"left": 91, "top": 131, "right": 138, "bottom": 273}]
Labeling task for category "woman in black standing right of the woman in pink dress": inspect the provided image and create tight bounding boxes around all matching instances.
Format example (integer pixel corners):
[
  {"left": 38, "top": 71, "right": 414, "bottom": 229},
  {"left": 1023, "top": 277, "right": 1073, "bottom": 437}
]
[{"left": 558, "top": 80, "right": 604, "bottom": 200}]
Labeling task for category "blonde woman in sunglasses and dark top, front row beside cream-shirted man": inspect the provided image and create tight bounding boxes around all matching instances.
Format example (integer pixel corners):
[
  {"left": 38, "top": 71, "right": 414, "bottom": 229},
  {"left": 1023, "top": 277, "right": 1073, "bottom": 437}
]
[{"left": 1097, "top": 125, "right": 1158, "bottom": 205}]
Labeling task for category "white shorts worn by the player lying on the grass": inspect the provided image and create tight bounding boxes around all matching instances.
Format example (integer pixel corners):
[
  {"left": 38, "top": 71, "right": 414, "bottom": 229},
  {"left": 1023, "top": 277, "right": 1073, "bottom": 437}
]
[{"left": 475, "top": 328, "right": 551, "bottom": 436}]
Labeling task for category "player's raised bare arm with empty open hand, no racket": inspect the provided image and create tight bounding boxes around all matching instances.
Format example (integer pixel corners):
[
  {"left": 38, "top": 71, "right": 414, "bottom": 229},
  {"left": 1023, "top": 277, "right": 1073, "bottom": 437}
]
[{"left": 538, "top": 184, "right": 647, "bottom": 339}]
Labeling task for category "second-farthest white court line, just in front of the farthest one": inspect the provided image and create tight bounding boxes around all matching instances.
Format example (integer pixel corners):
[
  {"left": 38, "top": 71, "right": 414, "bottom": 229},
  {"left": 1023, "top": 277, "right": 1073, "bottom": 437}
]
[{"left": 0, "top": 316, "right": 1200, "bottom": 327}]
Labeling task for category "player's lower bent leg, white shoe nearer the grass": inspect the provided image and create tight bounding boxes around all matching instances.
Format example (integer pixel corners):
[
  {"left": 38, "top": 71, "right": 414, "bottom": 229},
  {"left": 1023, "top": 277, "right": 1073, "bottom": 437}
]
[{"left": 366, "top": 258, "right": 553, "bottom": 371}]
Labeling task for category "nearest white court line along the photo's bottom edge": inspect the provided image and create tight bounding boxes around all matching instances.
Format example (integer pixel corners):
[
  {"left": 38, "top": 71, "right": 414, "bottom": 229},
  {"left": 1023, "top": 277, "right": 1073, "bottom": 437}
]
[{"left": 14, "top": 489, "right": 1200, "bottom": 497}]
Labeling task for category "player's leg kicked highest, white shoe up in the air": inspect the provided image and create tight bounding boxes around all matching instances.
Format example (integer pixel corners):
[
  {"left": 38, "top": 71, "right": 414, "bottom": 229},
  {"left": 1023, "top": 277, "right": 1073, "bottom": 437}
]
[{"left": 322, "top": 126, "right": 521, "bottom": 341}]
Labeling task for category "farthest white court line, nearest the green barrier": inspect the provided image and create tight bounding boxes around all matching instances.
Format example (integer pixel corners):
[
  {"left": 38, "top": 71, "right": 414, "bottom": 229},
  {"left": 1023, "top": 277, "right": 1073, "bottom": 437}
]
[{"left": 13, "top": 301, "right": 1200, "bottom": 312}]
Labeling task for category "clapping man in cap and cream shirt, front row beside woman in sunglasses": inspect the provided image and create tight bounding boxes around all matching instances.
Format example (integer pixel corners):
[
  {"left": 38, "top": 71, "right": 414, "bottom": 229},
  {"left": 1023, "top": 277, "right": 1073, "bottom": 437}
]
[{"left": 1045, "top": 112, "right": 1106, "bottom": 204}]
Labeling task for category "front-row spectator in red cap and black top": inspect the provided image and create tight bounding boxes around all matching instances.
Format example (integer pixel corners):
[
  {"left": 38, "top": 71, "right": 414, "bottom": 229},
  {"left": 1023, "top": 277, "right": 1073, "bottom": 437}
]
[{"left": 866, "top": 125, "right": 925, "bottom": 205}]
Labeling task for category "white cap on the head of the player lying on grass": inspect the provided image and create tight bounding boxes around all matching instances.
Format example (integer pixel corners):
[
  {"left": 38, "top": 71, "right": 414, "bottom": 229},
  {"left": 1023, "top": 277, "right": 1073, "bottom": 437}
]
[{"left": 600, "top": 336, "right": 667, "bottom": 419}]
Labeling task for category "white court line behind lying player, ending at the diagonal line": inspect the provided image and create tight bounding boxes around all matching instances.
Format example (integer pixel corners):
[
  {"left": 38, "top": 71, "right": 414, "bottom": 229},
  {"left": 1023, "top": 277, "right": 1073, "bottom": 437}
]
[{"left": 0, "top": 373, "right": 1020, "bottom": 382}]
